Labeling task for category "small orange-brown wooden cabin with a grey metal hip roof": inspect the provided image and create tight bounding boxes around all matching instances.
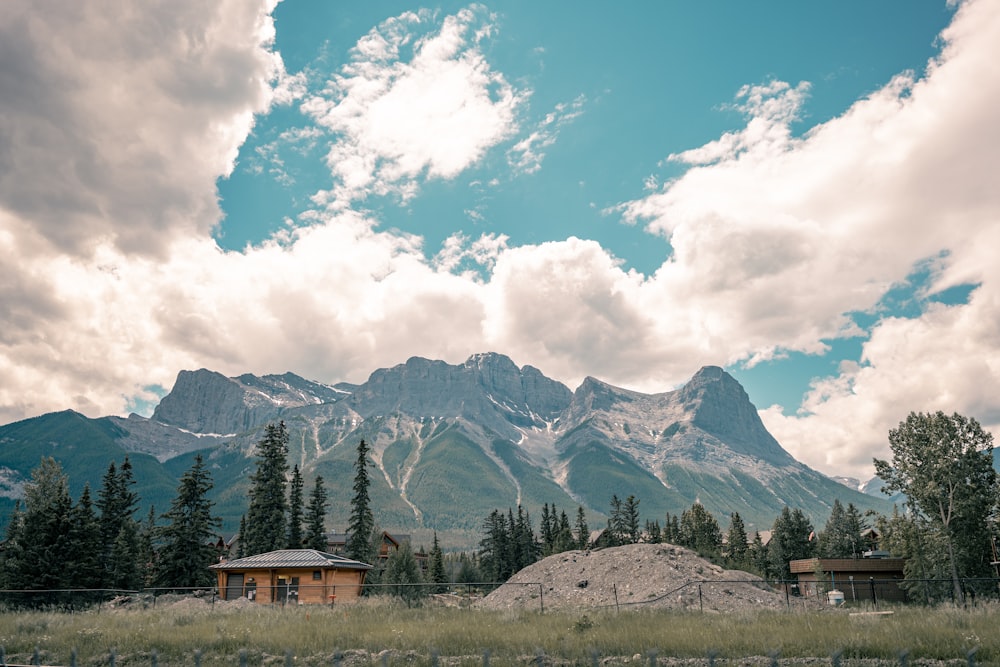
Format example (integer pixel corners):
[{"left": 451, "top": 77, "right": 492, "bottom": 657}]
[{"left": 209, "top": 549, "right": 372, "bottom": 604}]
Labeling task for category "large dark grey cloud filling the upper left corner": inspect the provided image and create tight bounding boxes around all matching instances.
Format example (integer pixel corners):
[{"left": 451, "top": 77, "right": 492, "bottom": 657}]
[{"left": 0, "top": 0, "right": 281, "bottom": 253}]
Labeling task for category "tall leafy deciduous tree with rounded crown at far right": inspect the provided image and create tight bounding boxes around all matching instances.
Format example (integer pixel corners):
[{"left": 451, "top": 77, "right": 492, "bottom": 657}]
[{"left": 875, "top": 411, "right": 997, "bottom": 603}]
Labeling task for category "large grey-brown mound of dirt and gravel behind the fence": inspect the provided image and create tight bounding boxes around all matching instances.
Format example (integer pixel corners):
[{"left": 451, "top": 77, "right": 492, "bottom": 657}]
[{"left": 479, "top": 544, "right": 786, "bottom": 612}]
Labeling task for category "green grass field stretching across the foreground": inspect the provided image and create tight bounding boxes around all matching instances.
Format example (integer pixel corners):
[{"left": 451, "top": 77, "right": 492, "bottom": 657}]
[{"left": 0, "top": 600, "right": 1000, "bottom": 667}]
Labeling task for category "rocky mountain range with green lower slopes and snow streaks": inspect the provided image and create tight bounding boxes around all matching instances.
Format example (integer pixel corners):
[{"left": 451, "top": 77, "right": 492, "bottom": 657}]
[{"left": 0, "top": 353, "right": 891, "bottom": 546}]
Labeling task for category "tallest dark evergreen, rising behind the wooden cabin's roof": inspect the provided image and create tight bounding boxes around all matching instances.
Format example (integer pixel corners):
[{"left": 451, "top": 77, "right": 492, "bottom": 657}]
[{"left": 240, "top": 421, "right": 288, "bottom": 556}]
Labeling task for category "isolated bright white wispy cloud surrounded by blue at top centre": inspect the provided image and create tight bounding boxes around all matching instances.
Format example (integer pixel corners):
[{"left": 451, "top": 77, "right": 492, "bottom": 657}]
[{"left": 302, "top": 5, "right": 527, "bottom": 210}]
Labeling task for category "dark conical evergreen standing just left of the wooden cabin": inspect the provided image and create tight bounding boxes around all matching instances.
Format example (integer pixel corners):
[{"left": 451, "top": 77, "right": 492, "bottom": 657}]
[{"left": 157, "top": 454, "right": 222, "bottom": 587}]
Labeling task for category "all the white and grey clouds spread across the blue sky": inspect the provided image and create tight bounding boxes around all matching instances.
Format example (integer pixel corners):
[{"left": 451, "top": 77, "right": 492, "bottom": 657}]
[{"left": 0, "top": 0, "right": 1000, "bottom": 476}]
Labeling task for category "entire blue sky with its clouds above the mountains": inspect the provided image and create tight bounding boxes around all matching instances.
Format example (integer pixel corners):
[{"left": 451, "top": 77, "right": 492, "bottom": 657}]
[{"left": 0, "top": 0, "right": 1000, "bottom": 480}]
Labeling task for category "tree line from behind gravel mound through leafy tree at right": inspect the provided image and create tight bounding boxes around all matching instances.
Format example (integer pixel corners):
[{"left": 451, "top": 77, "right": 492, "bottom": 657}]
[{"left": 479, "top": 412, "right": 1000, "bottom": 602}]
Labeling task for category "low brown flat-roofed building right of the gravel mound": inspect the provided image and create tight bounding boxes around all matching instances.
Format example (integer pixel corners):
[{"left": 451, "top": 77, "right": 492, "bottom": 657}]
[{"left": 788, "top": 558, "right": 906, "bottom": 602}]
